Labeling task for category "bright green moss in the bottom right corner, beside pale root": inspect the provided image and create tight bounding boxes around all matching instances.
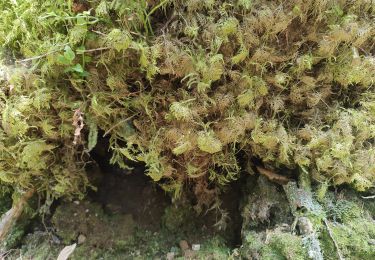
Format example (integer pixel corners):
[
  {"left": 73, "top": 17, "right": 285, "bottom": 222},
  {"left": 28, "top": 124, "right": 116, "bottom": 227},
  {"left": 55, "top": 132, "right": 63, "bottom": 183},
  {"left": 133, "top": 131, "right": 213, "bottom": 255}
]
[{"left": 320, "top": 190, "right": 375, "bottom": 259}]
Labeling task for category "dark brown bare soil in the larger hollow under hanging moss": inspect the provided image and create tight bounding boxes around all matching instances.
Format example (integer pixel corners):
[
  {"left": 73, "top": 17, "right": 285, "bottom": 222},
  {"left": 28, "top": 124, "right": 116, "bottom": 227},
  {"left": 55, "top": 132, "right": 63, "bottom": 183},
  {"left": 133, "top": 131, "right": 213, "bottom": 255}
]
[{"left": 93, "top": 167, "right": 170, "bottom": 230}]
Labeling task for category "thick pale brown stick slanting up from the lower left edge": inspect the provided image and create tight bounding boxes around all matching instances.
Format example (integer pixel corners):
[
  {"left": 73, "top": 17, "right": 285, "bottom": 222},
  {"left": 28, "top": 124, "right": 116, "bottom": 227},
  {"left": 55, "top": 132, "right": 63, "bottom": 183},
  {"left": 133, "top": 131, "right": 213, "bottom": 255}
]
[{"left": 0, "top": 189, "right": 35, "bottom": 243}]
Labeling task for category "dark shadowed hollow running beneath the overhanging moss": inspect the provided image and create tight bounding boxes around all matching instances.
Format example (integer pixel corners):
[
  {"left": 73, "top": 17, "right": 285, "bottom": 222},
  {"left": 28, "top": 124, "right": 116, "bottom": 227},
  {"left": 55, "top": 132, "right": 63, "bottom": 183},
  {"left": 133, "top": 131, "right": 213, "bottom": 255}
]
[{"left": 89, "top": 133, "right": 247, "bottom": 248}]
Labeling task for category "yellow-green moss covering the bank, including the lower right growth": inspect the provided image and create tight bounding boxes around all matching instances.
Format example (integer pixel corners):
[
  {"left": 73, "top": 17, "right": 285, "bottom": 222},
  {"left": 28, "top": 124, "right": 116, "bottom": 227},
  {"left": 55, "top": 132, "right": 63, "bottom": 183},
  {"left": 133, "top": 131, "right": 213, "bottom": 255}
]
[{"left": 0, "top": 0, "right": 375, "bottom": 259}]
